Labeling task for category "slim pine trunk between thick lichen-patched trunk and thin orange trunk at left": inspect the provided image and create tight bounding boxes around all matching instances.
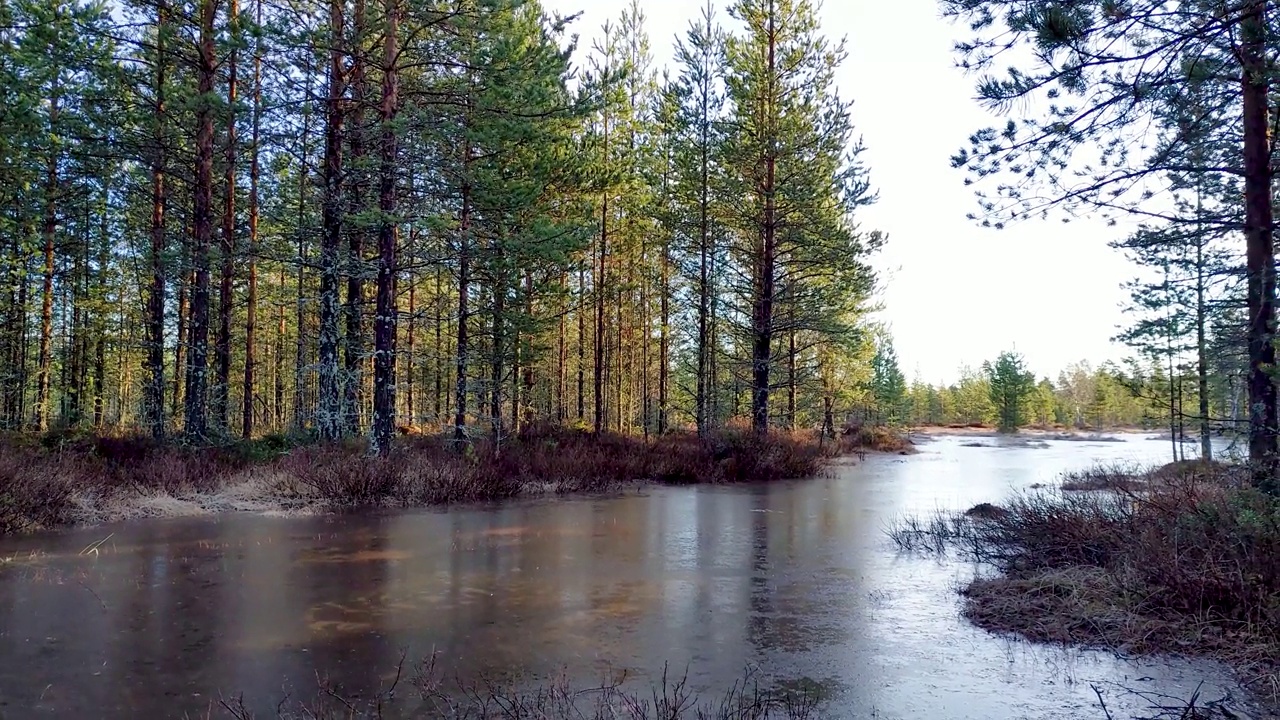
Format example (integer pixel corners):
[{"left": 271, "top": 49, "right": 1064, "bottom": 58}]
[{"left": 212, "top": 0, "right": 239, "bottom": 433}]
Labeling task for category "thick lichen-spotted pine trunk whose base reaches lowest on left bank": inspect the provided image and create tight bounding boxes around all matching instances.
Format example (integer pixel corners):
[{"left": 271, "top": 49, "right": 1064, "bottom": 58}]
[{"left": 374, "top": 0, "right": 399, "bottom": 455}]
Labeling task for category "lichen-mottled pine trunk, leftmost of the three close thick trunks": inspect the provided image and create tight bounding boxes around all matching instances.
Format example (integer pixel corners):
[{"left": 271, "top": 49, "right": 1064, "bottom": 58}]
[{"left": 316, "top": 0, "right": 346, "bottom": 441}]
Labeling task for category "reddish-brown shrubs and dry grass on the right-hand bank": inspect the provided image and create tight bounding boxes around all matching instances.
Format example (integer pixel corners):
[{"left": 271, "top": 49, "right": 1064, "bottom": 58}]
[{"left": 890, "top": 462, "right": 1280, "bottom": 694}]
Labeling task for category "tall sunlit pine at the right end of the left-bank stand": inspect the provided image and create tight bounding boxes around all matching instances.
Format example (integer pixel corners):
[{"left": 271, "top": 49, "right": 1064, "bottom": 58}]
[{"left": 726, "top": 0, "right": 882, "bottom": 433}]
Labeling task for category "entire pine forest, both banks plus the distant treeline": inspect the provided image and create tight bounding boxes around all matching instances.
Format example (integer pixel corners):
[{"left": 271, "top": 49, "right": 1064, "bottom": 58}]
[{"left": 0, "top": 0, "right": 1276, "bottom": 460}]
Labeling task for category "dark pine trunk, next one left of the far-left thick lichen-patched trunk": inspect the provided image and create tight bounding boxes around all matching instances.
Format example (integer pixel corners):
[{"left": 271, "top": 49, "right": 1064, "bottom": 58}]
[{"left": 143, "top": 0, "right": 169, "bottom": 439}]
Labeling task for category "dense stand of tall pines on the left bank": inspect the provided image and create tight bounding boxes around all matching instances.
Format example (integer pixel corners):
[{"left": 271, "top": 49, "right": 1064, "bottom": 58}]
[{"left": 0, "top": 0, "right": 883, "bottom": 451}]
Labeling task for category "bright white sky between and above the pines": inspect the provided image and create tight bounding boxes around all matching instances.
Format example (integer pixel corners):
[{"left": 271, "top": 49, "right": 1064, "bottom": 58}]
[{"left": 543, "top": 0, "right": 1135, "bottom": 383}]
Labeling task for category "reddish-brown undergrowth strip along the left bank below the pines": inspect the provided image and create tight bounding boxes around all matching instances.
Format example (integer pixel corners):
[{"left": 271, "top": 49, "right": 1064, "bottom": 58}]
[{"left": 0, "top": 427, "right": 840, "bottom": 534}]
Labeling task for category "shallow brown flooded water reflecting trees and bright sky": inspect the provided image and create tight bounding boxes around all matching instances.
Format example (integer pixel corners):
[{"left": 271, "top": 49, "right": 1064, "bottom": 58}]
[{"left": 0, "top": 437, "right": 1259, "bottom": 719}]
